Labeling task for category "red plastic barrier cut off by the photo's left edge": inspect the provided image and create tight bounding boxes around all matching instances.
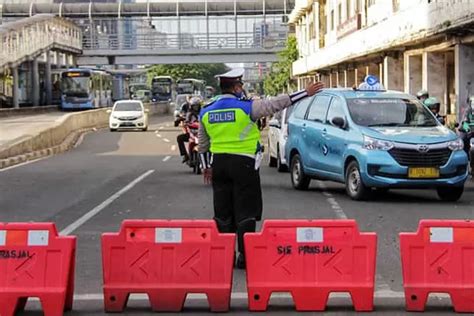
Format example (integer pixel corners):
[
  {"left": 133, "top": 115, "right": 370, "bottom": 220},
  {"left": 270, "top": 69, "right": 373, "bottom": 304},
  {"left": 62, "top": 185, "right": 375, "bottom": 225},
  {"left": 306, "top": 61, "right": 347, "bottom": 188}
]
[{"left": 0, "top": 223, "right": 76, "bottom": 316}]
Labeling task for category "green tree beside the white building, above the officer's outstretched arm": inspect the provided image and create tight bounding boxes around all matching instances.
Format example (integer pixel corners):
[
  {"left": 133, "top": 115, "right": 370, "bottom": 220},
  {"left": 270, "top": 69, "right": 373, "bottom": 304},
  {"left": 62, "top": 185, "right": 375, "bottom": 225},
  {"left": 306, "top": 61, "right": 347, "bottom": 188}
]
[{"left": 263, "top": 36, "right": 298, "bottom": 95}]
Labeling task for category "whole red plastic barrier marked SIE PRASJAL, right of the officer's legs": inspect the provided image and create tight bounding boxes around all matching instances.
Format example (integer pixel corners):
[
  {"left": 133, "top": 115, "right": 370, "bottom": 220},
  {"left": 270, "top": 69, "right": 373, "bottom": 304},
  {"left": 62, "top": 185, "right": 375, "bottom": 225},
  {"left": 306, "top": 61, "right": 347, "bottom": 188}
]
[{"left": 245, "top": 220, "right": 377, "bottom": 311}]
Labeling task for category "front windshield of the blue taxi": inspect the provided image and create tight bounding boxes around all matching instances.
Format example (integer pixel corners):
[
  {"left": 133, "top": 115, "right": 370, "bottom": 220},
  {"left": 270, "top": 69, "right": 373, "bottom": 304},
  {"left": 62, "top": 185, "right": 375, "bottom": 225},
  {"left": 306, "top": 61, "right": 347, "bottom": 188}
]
[{"left": 347, "top": 98, "right": 438, "bottom": 127}]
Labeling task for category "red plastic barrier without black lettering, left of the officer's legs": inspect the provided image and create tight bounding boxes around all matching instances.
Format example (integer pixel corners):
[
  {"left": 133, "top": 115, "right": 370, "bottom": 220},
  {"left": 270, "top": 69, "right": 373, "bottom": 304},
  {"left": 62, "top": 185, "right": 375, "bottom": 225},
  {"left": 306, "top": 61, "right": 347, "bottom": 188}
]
[{"left": 102, "top": 220, "right": 235, "bottom": 312}]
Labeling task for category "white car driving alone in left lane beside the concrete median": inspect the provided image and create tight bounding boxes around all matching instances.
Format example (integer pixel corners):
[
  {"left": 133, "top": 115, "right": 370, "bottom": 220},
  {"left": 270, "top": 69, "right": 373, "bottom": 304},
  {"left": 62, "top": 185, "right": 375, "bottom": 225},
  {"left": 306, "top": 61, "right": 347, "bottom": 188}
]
[{"left": 107, "top": 100, "right": 148, "bottom": 132}]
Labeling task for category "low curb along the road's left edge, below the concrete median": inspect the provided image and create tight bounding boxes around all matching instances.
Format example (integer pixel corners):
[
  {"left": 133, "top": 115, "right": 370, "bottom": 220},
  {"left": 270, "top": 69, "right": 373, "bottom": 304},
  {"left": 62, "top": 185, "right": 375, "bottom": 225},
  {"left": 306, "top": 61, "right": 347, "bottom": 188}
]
[{"left": 0, "top": 127, "right": 101, "bottom": 170}]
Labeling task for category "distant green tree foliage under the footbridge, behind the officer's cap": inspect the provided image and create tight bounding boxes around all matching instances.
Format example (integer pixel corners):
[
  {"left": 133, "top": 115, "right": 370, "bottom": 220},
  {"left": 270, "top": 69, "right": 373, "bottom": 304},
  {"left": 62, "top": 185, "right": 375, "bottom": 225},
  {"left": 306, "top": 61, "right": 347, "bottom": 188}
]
[{"left": 148, "top": 64, "right": 228, "bottom": 88}]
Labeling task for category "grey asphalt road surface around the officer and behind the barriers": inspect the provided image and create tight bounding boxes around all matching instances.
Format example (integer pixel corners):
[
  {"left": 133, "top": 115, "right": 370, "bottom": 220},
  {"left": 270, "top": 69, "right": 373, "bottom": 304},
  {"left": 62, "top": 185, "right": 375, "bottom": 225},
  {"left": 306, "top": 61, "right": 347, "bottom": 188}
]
[{"left": 0, "top": 118, "right": 474, "bottom": 315}]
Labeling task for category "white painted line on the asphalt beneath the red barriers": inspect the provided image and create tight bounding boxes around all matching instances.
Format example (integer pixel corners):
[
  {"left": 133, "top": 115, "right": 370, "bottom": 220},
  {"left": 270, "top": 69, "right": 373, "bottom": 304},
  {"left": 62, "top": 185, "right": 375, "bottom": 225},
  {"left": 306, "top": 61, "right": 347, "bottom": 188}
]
[{"left": 70, "top": 290, "right": 449, "bottom": 301}]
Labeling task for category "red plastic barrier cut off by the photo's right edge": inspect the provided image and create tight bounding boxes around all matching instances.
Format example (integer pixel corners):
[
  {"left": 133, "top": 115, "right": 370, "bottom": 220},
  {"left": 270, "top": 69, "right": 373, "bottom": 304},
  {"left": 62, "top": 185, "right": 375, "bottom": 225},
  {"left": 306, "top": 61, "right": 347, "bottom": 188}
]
[{"left": 400, "top": 220, "right": 474, "bottom": 313}]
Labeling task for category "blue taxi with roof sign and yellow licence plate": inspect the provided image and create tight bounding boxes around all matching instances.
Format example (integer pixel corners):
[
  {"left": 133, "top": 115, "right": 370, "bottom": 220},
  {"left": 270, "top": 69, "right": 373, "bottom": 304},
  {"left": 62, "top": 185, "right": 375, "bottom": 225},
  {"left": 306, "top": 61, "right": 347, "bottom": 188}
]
[{"left": 285, "top": 76, "right": 468, "bottom": 201}]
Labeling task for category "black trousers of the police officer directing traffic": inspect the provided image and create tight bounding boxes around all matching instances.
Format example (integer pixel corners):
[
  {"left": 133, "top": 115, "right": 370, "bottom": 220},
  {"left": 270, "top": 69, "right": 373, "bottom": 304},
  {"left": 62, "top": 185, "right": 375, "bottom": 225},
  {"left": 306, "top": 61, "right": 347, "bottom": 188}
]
[{"left": 212, "top": 154, "right": 262, "bottom": 254}]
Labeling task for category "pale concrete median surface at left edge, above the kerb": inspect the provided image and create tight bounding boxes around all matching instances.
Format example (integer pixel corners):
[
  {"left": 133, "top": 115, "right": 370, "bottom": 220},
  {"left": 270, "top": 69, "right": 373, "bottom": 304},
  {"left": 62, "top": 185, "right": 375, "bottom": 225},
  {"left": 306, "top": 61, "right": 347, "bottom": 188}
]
[{"left": 0, "top": 112, "right": 68, "bottom": 150}]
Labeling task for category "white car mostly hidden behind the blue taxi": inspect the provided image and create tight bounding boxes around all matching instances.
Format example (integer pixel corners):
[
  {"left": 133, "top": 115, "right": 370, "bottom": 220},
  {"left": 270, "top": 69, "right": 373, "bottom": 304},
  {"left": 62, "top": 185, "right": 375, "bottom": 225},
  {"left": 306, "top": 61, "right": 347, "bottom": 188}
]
[{"left": 268, "top": 107, "right": 293, "bottom": 172}]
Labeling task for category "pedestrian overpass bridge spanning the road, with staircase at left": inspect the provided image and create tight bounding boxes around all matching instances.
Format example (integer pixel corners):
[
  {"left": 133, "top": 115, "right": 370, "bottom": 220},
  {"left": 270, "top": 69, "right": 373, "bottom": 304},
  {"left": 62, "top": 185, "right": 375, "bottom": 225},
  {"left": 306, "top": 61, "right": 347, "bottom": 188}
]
[{"left": 0, "top": 0, "right": 295, "bottom": 107}]
